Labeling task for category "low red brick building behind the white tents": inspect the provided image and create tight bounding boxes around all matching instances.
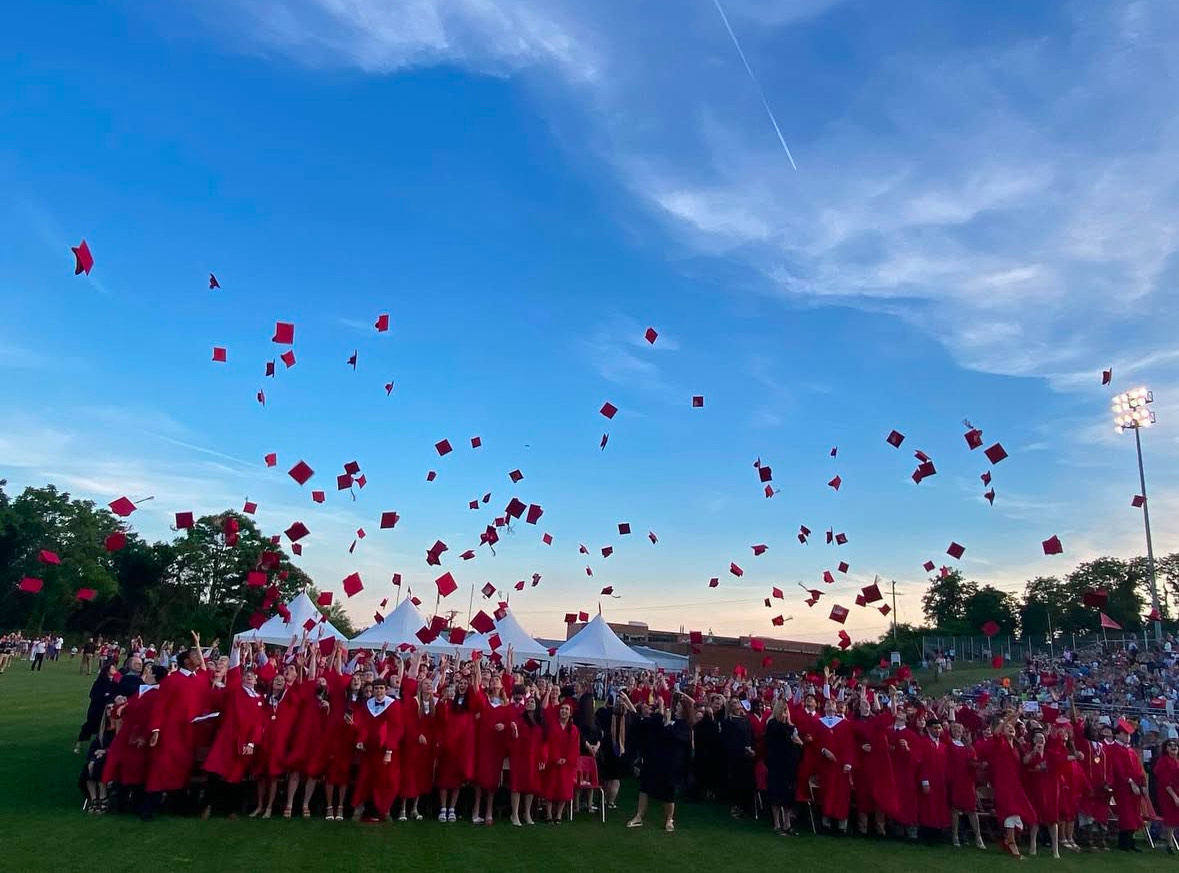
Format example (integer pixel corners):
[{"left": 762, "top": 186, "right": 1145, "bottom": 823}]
[{"left": 565, "top": 622, "right": 823, "bottom": 676}]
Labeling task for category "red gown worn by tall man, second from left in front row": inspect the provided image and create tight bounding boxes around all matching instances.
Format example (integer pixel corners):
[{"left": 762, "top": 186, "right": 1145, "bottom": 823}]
[{"left": 146, "top": 670, "right": 209, "bottom": 792}]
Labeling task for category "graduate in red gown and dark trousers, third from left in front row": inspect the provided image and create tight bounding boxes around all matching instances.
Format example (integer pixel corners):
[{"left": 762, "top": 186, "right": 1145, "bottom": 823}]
[{"left": 203, "top": 646, "right": 268, "bottom": 818}]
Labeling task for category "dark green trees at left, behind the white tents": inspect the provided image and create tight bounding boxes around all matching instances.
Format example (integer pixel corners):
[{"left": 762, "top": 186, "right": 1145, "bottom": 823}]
[{"left": 0, "top": 480, "right": 353, "bottom": 642}]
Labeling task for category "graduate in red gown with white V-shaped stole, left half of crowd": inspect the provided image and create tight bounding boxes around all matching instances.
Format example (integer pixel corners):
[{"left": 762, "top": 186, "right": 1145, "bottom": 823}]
[{"left": 353, "top": 676, "right": 404, "bottom": 821}]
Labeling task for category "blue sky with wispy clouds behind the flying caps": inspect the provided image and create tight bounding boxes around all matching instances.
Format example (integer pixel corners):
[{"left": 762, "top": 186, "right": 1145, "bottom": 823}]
[{"left": 0, "top": 0, "right": 1179, "bottom": 641}]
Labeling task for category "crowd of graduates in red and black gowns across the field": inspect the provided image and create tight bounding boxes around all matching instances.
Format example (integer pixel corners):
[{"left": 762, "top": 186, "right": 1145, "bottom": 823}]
[{"left": 75, "top": 638, "right": 1179, "bottom": 856}]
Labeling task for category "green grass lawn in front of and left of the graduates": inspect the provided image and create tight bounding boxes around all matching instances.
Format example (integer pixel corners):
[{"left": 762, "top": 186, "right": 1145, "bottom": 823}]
[{"left": 0, "top": 662, "right": 1160, "bottom": 873}]
